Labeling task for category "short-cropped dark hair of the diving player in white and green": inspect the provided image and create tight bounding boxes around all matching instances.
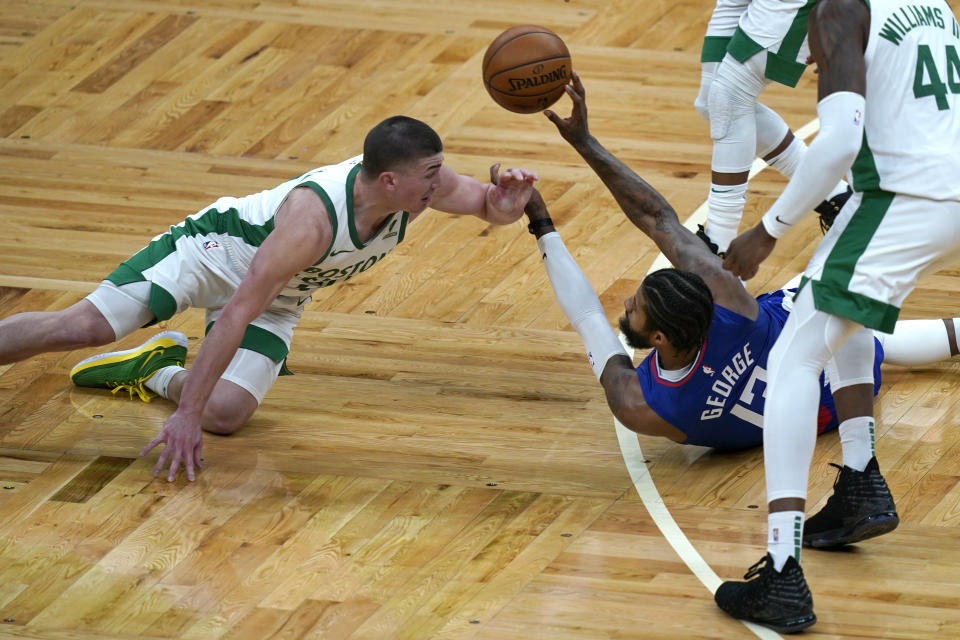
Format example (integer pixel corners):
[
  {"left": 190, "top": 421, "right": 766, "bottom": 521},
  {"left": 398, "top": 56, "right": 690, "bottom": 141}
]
[{"left": 363, "top": 116, "right": 443, "bottom": 180}]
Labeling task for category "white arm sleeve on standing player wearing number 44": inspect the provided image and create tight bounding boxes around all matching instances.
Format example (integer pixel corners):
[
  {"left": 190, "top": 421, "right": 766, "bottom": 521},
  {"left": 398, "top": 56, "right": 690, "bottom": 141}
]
[{"left": 763, "top": 91, "right": 865, "bottom": 238}]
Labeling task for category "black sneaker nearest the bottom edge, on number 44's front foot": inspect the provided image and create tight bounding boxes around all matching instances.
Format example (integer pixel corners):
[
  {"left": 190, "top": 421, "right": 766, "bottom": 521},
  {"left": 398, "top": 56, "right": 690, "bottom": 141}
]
[{"left": 713, "top": 553, "right": 817, "bottom": 633}]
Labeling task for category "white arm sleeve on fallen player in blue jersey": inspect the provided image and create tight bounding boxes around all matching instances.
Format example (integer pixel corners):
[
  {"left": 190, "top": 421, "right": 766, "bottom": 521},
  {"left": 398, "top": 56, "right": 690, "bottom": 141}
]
[{"left": 537, "top": 231, "right": 630, "bottom": 380}]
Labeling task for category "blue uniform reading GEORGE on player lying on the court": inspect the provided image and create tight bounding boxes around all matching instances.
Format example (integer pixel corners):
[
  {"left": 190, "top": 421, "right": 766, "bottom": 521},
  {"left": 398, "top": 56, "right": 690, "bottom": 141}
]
[{"left": 637, "top": 291, "right": 883, "bottom": 449}]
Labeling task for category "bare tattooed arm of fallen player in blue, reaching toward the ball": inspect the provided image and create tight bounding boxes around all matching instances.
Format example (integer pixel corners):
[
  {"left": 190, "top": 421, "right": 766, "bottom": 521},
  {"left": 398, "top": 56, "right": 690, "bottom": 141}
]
[{"left": 544, "top": 72, "right": 757, "bottom": 320}]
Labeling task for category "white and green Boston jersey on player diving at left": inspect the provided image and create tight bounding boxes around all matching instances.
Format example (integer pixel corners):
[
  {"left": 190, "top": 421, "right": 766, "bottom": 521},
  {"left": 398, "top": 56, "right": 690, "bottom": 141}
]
[{"left": 167, "top": 156, "right": 409, "bottom": 307}]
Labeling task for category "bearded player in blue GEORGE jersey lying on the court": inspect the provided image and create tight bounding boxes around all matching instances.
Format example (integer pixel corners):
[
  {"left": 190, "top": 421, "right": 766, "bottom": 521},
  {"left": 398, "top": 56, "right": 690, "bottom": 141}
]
[{"left": 526, "top": 74, "right": 960, "bottom": 456}]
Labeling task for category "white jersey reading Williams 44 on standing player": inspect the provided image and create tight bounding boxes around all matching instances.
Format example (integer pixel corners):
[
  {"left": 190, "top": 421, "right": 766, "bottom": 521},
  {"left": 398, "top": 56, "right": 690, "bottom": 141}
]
[{"left": 851, "top": 0, "right": 960, "bottom": 200}]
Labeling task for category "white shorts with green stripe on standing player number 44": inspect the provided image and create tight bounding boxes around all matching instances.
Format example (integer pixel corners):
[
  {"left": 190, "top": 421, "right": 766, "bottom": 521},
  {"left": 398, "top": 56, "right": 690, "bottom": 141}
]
[{"left": 804, "top": 191, "right": 960, "bottom": 333}]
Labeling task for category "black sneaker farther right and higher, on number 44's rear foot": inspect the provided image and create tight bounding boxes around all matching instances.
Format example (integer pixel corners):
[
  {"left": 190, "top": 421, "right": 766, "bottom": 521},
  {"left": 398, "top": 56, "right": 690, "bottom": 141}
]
[{"left": 803, "top": 457, "right": 900, "bottom": 549}]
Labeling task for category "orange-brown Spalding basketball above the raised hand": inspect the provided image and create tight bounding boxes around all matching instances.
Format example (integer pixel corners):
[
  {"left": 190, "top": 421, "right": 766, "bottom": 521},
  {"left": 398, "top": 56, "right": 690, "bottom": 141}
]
[{"left": 483, "top": 24, "right": 571, "bottom": 113}]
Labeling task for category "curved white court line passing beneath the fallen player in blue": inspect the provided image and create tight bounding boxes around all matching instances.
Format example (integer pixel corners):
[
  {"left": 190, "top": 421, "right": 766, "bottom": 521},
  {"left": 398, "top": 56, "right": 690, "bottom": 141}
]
[{"left": 613, "top": 120, "right": 820, "bottom": 640}]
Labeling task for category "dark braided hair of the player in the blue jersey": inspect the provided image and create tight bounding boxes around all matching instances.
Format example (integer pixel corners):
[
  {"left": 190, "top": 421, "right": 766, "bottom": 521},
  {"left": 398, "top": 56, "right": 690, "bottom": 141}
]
[{"left": 640, "top": 269, "right": 713, "bottom": 351}]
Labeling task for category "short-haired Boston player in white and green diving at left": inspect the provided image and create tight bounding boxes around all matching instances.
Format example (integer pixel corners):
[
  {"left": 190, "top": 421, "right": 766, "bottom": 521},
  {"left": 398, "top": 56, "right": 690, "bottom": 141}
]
[{"left": 0, "top": 116, "right": 537, "bottom": 481}]
